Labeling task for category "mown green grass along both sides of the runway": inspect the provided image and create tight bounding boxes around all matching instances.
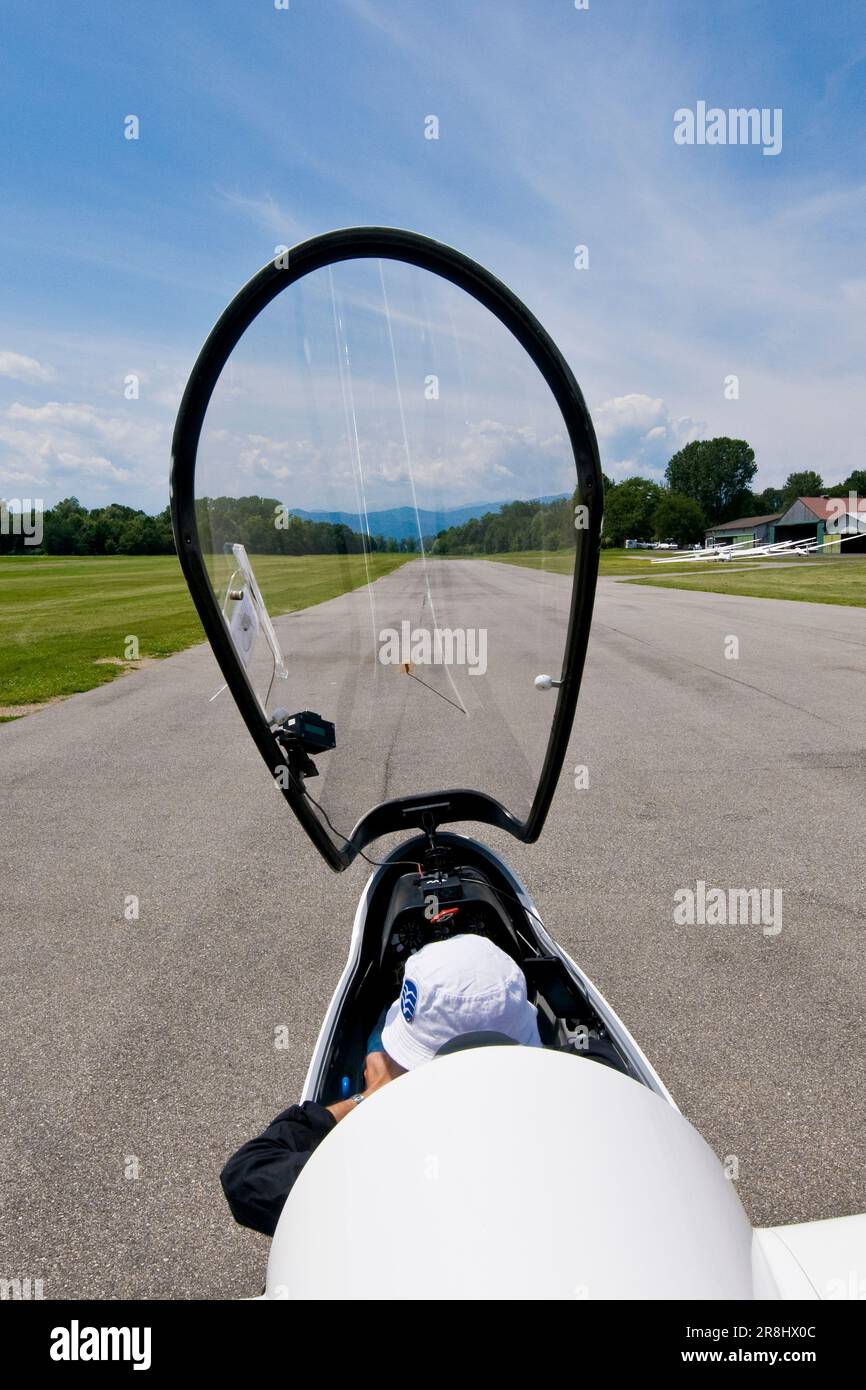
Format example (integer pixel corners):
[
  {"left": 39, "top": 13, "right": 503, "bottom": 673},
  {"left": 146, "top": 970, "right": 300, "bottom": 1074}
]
[{"left": 6, "top": 550, "right": 866, "bottom": 723}]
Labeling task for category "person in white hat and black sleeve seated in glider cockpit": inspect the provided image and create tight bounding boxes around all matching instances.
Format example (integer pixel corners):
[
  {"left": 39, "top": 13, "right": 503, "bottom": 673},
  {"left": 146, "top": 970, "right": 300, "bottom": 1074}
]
[{"left": 221, "top": 935, "right": 541, "bottom": 1236}]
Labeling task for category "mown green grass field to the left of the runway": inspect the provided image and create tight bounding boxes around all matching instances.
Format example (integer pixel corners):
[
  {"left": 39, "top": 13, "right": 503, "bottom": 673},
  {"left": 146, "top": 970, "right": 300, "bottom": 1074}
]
[{"left": 0, "top": 555, "right": 410, "bottom": 719}]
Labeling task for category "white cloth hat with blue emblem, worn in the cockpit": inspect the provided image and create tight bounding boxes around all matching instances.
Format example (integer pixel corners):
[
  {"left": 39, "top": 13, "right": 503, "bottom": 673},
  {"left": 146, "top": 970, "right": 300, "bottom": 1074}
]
[{"left": 382, "top": 935, "right": 541, "bottom": 1070}]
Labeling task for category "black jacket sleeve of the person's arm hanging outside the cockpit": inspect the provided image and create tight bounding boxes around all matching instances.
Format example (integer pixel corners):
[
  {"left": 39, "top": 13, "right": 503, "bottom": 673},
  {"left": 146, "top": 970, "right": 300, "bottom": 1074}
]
[{"left": 220, "top": 1101, "right": 336, "bottom": 1236}]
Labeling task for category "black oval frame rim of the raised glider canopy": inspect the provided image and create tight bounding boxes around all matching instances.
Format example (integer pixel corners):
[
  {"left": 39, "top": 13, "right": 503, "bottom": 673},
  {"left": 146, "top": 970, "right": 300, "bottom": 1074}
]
[{"left": 171, "top": 227, "right": 603, "bottom": 872}]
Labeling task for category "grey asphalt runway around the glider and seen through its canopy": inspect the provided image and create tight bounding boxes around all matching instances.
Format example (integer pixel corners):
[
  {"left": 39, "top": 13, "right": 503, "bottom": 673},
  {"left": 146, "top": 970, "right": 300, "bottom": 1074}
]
[{"left": 0, "top": 560, "right": 866, "bottom": 1298}]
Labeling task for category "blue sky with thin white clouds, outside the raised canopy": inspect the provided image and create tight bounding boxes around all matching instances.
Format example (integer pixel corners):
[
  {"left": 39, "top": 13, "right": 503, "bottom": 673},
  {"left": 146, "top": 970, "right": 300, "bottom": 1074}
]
[{"left": 0, "top": 0, "right": 866, "bottom": 510}]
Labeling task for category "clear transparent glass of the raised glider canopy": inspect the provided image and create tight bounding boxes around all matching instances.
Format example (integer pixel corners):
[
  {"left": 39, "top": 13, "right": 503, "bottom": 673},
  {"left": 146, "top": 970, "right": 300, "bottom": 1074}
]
[{"left": 196, "top": 259, "right": 582, "bottom": 840}]
